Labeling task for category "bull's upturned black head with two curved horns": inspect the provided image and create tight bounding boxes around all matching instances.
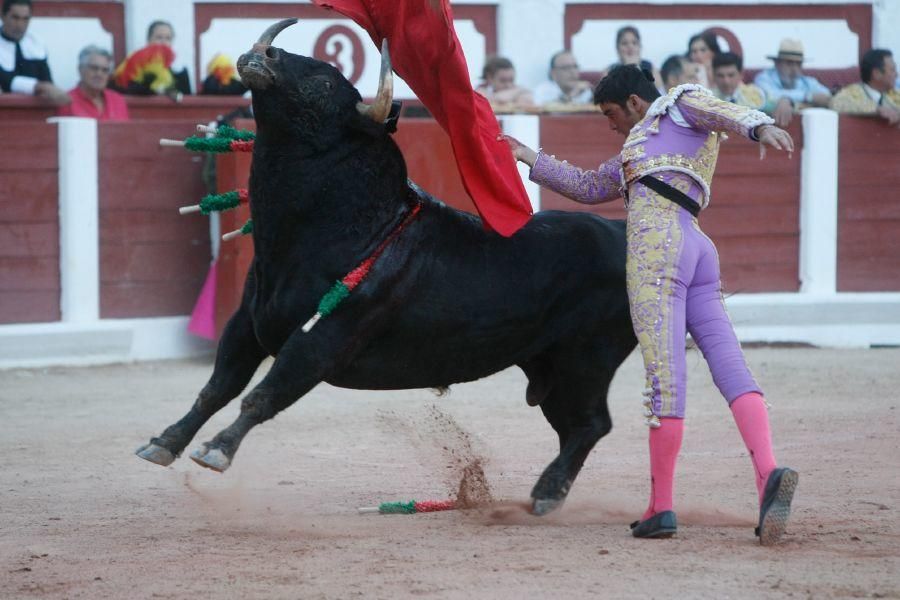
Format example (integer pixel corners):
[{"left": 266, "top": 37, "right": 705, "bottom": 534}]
[{"left": 237, "top": 19, "right": 394, "bottom": 142}]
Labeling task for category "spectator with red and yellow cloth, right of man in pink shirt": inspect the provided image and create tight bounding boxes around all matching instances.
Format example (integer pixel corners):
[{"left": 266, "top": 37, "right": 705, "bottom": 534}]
[{"left": 112, "top": 21, "right": 191, "bottom": 101}]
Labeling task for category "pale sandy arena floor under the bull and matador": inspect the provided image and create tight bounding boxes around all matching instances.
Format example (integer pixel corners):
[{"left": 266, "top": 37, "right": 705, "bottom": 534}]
[{"left": 0, "top": 348, "right": 900, "bottom": 600}]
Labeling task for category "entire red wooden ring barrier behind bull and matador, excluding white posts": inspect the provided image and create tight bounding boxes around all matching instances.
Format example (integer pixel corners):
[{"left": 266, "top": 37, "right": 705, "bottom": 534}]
[{"left": 0, "top": 110, "right": 900, "bottom": 327}]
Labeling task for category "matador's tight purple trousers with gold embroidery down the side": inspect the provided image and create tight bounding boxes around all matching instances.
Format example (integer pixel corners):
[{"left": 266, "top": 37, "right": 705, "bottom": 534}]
[{"left": 626, "top": 173, "right": 762, "bottom": 418}]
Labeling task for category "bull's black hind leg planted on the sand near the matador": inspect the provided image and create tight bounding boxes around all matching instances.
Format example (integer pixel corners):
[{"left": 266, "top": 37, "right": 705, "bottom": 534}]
[{"left": 531, "top": 373, "right": 612, "bottom": 515}]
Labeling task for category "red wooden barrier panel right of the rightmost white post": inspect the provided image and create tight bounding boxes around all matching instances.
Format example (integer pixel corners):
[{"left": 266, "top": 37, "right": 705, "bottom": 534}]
[{"left": 837, "top": 115, "right": 900, "bottom": 292}]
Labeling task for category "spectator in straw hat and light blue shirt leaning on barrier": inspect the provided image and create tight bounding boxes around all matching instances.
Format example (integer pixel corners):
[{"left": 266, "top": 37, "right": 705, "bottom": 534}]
[{"left": 754, "top": 39, "right": 831, "bottom": 127}]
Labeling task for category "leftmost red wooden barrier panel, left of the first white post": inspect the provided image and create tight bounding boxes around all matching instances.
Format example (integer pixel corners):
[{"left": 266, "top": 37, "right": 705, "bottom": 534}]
[{"left": 0, "top": 122, "right": 60, "bottom": 323}]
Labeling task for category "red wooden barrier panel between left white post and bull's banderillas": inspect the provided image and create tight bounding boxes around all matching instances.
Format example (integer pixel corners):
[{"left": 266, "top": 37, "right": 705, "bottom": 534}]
[{"left": 99, "top": 120, "right": 210, "bottom": 318}]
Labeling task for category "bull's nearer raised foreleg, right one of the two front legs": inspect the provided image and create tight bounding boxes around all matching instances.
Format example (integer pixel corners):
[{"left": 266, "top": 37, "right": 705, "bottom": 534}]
[{"left": 190, "top": 317, "right": 365, "bottom": 473}]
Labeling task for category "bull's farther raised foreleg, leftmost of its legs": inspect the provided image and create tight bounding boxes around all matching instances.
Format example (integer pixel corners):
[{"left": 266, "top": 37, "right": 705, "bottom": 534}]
[{"left": 135, "top": 305, "right": 267, "bottom": 466}]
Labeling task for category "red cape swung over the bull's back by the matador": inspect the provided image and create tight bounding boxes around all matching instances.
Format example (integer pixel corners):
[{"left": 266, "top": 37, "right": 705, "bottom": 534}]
[{"left": 313, "top": 0, "right": 531, "bottom": 236}]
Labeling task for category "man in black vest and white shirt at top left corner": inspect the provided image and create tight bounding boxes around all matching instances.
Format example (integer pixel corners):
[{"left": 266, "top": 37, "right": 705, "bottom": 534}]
[{"left": 0, "top": 0, "right": 69, "bottom": 106}]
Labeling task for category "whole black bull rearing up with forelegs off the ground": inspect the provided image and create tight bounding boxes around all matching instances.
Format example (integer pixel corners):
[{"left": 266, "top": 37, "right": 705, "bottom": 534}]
[{"left": 137, "top": 20, "right": 635, "bottom": 514}]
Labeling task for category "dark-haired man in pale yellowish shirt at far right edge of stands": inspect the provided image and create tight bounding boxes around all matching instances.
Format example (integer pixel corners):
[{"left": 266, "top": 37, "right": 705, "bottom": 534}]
[{"left": 831, "top": 48, "right": 900, "bottom": 125}]
